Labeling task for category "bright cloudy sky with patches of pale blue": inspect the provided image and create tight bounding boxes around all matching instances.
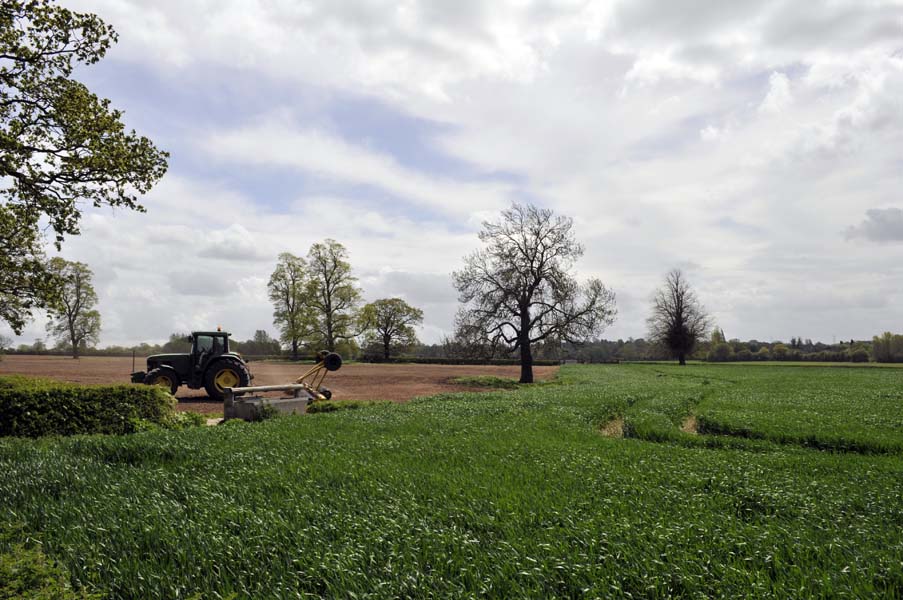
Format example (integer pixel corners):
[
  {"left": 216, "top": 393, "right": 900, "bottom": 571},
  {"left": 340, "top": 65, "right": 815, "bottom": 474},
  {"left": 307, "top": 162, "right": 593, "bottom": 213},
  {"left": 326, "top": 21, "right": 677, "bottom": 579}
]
[{"left": 0, "top": 0, "right": 903, "bottom": 345}]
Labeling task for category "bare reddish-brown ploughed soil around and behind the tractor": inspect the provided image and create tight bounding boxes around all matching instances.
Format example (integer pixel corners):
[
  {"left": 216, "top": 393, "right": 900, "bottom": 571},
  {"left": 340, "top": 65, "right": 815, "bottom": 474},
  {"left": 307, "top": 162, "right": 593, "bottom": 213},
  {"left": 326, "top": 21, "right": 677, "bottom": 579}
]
[{"left": 0, "top": 355, "right": 558, "bottom": 413}]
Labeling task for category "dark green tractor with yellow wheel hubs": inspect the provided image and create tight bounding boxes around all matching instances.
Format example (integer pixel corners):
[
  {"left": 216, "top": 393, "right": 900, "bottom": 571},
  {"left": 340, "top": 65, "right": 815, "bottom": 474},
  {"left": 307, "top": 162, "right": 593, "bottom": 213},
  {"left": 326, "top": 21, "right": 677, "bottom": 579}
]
[{"left": 132, "top": 331, "right": 252, "bottom": 402}]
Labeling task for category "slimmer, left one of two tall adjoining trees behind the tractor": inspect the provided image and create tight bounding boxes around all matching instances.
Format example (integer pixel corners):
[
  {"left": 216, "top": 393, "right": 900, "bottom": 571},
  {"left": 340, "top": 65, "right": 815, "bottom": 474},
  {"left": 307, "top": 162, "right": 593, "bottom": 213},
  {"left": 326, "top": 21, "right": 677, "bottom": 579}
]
[{"left": 267, "top": 252, "right": 311, "bottom": 360}]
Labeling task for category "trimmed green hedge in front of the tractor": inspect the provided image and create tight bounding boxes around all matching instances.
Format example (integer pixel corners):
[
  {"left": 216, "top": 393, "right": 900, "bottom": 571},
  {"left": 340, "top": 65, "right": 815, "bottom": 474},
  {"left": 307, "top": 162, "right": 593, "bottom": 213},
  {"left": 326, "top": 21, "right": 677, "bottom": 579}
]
[{"left": 0, "top": 375, "right": 176, "bottom": 437}]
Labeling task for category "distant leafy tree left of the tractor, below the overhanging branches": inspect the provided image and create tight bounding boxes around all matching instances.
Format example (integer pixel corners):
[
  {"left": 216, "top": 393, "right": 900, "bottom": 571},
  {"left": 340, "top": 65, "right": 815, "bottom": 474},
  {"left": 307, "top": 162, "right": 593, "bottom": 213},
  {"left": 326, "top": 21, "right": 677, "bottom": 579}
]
[{"left": 47, "top": 257, "right": 100, "bottom": 358}]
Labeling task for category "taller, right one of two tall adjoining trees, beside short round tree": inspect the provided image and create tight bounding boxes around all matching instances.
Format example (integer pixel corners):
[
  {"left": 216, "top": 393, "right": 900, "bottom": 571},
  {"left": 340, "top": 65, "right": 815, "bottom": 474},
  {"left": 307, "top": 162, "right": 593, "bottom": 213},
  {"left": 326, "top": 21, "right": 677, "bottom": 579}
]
[{"left": 305, "top": 239, "right": 361, "bottom": 352}]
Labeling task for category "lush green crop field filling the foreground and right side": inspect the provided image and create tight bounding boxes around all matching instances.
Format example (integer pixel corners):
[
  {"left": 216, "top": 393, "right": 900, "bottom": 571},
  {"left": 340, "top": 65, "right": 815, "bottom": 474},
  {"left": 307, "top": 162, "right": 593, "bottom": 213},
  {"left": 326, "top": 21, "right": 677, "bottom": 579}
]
[{"left": 0, "top": 364, "right": 903, "bottom": 598}]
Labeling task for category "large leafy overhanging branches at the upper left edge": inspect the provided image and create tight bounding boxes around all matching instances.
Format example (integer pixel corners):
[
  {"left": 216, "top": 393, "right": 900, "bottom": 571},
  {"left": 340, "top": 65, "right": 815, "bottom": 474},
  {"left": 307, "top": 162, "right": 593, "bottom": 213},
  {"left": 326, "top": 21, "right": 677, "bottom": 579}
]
[{"left": 0, "top": 0, "right": 168, "bottom": 333}]
